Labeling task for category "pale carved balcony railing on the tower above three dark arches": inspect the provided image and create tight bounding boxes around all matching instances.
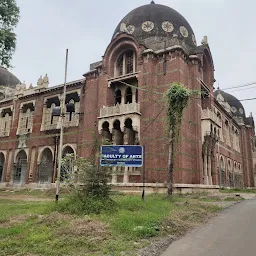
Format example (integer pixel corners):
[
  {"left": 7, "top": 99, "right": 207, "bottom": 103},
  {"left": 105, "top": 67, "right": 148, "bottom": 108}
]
[{"left": 99, "top": 102, "right": 140, "bottom": 118}]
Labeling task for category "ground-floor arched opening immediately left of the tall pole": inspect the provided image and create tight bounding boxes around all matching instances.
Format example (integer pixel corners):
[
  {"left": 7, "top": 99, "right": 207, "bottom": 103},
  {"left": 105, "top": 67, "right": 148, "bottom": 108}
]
[{"left": 38, "top": 148, "right": 53, "bottom": 183}]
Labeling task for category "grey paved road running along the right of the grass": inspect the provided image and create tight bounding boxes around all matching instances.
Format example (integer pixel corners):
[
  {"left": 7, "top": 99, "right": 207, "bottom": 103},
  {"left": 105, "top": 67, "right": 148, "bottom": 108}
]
[{"left": 162, "top": 199, "right": 256, "bottom": 256}]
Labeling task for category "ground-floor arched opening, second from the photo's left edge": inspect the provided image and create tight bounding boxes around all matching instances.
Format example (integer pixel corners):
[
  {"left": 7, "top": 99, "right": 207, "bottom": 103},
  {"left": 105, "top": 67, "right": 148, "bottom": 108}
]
[{"left": 13, "top": 150, "right": 27, "bottom": 183}]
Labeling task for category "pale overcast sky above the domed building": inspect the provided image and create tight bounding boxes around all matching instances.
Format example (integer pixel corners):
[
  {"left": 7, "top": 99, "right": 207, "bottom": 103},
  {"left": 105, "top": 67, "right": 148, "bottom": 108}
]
[{"left": 12, "top": 0, "right": 256, "bottom": 117}]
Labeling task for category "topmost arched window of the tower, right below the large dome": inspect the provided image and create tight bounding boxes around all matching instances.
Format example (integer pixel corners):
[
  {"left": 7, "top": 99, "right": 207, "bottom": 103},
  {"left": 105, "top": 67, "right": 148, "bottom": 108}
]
[{"left": 116, "top": 50, "right": 136, "bottom": 76}]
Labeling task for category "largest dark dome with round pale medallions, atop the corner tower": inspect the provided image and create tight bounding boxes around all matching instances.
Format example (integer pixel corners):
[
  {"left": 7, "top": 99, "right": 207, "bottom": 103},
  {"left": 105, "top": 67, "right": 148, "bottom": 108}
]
[{"left": 112, "top": 1, "right": 196, "bottom": 50}]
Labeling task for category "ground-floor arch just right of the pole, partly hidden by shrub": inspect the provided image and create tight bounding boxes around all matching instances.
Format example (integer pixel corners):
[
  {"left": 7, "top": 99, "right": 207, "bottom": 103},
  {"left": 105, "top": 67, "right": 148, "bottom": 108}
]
[{"left": 60, "top": 146, "right": 75, "bottom": 182}]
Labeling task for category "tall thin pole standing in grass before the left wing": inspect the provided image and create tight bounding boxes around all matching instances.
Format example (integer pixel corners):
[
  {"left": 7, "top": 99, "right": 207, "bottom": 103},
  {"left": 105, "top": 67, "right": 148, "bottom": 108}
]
[{"left": 56, "top": 49, "right": 68, "bottom": 202}]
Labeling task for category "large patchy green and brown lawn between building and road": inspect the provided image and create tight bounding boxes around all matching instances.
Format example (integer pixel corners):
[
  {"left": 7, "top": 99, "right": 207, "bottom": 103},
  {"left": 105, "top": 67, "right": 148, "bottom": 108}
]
[{"left": 0, "top": 192, "right": 227, "bottom": 256}]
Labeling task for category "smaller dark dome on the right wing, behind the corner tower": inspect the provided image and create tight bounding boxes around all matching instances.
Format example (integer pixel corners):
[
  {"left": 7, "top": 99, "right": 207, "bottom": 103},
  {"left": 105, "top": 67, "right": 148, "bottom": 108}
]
[{"left": 214, "top": 90, "right": 246, "bottom": 119}]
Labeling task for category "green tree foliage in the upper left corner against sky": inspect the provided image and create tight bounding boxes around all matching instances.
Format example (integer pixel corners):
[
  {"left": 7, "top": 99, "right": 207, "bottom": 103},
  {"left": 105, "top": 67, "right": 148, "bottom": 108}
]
[{"left": 0, "top": 0, "right": 20, "bottom": 67}]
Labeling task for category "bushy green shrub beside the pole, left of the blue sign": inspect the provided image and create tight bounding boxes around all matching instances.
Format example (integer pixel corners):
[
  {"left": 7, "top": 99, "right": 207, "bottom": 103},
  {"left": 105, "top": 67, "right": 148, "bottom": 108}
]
[{"left": 57, "top": 155, "right": 115, "bottom": 215}]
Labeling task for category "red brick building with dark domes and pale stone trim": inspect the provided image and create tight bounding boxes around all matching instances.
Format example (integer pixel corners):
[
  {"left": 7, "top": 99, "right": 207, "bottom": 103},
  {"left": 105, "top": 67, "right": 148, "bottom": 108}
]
[{"left": 0, "top": 1, "right": 256, "bottom": 188}]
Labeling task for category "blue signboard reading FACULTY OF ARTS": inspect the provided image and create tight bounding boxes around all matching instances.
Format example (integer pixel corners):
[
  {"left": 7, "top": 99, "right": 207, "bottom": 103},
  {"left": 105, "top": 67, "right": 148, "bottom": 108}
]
[{"left": 100, "top": 145, "right": 143, "bottom": 167}]
